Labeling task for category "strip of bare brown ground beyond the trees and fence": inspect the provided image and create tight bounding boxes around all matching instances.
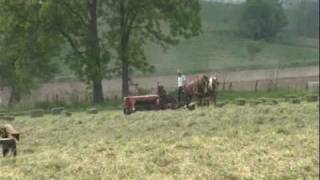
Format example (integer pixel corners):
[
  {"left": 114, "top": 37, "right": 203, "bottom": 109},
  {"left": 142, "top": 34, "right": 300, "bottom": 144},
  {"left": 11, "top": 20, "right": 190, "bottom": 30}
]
[{"left": 0, "top": 66, "right": 319, "bottom": 104}]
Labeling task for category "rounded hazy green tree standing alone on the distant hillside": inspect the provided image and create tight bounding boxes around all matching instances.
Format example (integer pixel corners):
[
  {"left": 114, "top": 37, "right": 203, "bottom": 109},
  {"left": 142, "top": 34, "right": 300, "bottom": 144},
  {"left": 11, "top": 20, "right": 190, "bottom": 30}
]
[{"left": 241, "top": 0, "right": 287, "bottom": 40}]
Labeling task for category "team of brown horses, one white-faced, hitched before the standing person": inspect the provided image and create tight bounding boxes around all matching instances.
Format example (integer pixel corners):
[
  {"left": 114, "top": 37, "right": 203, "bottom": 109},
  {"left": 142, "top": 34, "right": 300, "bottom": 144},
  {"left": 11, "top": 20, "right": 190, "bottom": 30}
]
[{"left": 184, "top": 74, "right": 219, "bottom": 106}]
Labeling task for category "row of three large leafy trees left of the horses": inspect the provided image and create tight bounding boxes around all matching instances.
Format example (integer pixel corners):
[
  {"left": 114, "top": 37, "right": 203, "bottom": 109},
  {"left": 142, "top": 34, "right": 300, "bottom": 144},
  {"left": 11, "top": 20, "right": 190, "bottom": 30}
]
[{"left": 0, "top": 0, "right": 201, "bottom": 103}]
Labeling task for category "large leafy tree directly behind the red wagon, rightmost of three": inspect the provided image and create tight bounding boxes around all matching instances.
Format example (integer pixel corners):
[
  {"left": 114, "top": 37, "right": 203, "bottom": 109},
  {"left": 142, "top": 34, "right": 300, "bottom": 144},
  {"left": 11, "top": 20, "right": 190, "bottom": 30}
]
[{"left": 105, "top": 0, "right": 201, "bottom": 96}]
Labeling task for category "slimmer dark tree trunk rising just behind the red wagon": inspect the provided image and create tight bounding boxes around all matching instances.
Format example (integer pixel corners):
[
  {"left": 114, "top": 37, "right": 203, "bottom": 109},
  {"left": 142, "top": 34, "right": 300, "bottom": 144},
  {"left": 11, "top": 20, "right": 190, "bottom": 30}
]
[{"left": 120, "top": 1, "right": 129, "bottom": 97}]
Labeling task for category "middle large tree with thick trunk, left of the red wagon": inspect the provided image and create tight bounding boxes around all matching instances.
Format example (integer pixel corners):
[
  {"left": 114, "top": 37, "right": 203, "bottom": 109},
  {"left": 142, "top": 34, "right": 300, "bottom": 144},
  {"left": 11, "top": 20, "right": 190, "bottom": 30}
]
[{"left": 43, "top": 0, "right": 109, "bottom": 104}]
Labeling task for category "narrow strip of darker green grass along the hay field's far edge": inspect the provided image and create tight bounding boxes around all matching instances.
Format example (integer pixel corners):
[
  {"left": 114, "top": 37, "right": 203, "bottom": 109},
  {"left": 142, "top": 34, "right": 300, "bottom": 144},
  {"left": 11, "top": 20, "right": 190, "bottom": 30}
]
[{"left": 0, "top": 89, "right": 315, "bottom": 114}]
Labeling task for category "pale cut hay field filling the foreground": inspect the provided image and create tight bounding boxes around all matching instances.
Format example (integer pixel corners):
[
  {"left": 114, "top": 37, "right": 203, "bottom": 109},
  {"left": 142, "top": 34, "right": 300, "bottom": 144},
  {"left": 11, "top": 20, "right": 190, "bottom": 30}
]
[{"left": 0, "top": 102, "right": 319, "bottom": 180}]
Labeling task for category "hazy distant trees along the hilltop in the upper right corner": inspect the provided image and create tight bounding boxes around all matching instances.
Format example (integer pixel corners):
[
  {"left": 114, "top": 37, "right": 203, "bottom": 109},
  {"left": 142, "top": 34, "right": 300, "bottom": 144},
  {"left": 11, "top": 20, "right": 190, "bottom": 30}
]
[{"left": 241, "top": 0, "right": 319, "bottom": 40}]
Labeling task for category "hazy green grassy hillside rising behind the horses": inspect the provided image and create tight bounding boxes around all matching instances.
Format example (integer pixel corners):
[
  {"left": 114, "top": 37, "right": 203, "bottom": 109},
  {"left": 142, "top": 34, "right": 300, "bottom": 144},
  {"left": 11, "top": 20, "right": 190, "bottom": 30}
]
[{"left": 146, "top": 2, "right": 319, "bottom": 74}]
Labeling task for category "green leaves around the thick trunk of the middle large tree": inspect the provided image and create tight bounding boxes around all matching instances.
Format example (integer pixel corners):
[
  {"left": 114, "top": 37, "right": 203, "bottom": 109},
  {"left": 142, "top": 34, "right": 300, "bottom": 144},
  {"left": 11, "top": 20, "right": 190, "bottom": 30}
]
[{"left": 52, "top": 0, "right": 110, "bottom": 81}]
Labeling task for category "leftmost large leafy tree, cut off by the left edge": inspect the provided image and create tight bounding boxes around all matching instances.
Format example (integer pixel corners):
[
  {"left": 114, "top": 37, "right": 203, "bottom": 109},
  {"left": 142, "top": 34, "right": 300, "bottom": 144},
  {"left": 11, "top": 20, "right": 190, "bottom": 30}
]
[{"left": 0, "top": 0, "right": 62, "bottom": 104}]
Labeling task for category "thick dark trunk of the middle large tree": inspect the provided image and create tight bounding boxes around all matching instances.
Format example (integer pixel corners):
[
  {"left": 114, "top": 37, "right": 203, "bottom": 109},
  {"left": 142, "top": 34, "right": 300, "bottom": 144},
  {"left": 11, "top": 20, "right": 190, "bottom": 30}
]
[{"left": 87, "top": 0, "right": 103, "bottom": 104}]
